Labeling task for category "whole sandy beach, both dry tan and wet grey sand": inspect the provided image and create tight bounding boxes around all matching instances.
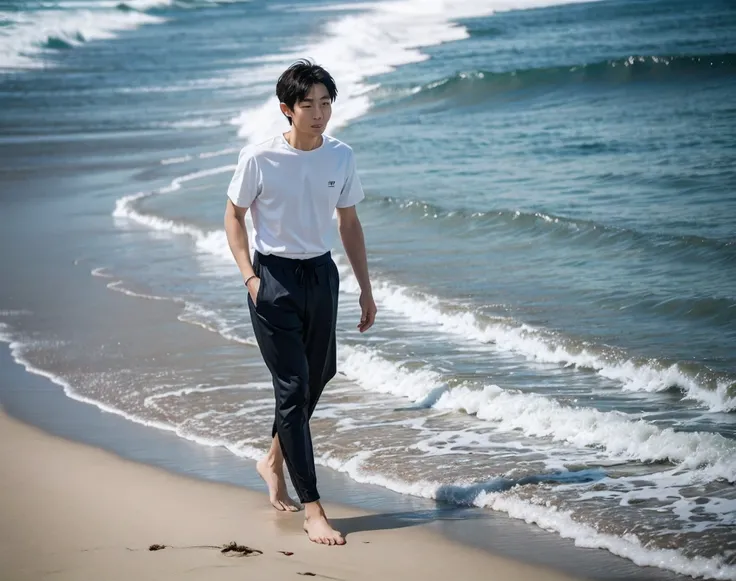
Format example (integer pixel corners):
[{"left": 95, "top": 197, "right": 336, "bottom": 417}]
[{"left": 0, "top": 334, "right": 696, "bottom": 581}]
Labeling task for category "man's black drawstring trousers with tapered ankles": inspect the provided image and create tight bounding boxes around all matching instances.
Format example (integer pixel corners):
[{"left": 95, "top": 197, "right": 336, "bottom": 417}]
[{"left": 248, "top": 252, "right": 340, "bottom": 502}]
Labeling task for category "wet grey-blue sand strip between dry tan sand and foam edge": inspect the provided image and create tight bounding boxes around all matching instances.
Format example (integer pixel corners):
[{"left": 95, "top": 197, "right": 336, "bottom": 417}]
[{"left": 0, "top": 344, "right": 686, "bottom": 581}]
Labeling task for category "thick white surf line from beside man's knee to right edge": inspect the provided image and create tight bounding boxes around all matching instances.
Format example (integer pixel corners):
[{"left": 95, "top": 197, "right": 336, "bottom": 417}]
[{"left": 339, "top": 345, "right": 736, "bottom": 482}]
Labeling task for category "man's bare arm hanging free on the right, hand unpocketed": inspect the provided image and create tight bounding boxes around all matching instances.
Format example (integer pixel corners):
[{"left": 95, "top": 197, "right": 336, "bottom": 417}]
[{"left": 337, "top": 206, "right": 377, "bottom": 333}]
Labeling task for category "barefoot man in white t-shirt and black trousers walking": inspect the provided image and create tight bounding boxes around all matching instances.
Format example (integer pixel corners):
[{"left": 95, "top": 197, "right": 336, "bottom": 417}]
[{"left": 225, "top": 61, "right": 376, "bottom": 545}]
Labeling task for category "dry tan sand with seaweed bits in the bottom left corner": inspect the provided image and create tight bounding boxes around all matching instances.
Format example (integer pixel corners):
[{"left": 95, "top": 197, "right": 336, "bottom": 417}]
[{"left": 0, "top": 410, "right": 588, "bottom": 581}]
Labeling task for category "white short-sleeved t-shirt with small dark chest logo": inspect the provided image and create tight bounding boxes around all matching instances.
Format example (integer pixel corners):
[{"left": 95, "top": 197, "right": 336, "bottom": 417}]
[{"left": 227, "top": 135, "right": 364, "bottom": 259}]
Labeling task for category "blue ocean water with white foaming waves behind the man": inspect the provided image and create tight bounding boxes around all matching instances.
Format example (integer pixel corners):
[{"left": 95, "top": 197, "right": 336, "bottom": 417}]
[{"left": 0, "top": 0, "right": 736, "bottom": 579}]
